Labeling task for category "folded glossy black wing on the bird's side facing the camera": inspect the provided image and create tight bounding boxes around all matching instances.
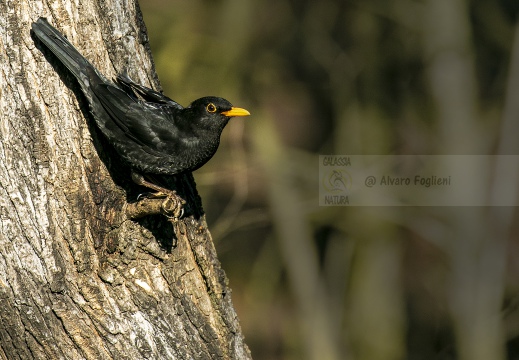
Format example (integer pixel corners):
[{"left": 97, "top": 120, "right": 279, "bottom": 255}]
[{"left": 93, "top": 83, "right": 185, "bottom": 155}]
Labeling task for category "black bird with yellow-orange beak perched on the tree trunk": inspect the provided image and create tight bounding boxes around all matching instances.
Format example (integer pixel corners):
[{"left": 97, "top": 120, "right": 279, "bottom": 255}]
[{"left": 32, "top": 18, "right": 250, "bottom": 215}]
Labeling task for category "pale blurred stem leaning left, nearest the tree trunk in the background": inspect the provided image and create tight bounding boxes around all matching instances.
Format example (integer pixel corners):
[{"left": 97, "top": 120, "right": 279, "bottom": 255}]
[{"left": 253, "top": 116, "right": 346, "bottom": 360}]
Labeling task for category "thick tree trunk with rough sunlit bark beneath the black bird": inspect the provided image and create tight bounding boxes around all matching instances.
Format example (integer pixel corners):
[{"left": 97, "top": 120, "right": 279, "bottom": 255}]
[{"left": 0, "top": 0, "right": 250, "bottom": 360}]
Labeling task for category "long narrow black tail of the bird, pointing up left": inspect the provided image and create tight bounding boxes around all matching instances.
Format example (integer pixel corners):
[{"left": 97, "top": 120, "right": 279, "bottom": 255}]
[{"left": 32, "top": 18, "right": 95, "bottom": 87}]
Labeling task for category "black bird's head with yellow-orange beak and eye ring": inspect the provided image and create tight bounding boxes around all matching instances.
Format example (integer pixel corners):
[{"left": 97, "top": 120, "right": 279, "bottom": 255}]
[{"left": 184, "top": 96, "right": 250, "bottom": 131}]
